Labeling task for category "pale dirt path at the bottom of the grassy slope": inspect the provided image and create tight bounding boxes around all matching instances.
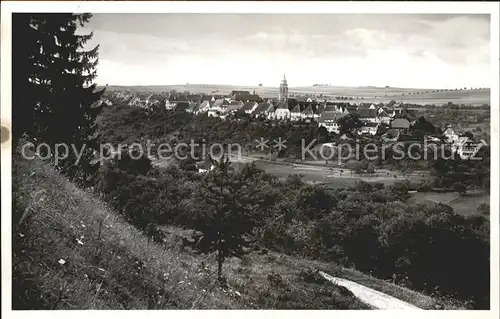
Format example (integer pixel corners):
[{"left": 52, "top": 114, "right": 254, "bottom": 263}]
[{"left": 320, "top": 271, "right": 422, "bottom": 310}]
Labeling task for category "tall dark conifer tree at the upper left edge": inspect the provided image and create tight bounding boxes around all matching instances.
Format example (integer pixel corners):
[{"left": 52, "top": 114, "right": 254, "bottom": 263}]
[{"left": 12, "top": 13, "right": 104, "bottom": 177}]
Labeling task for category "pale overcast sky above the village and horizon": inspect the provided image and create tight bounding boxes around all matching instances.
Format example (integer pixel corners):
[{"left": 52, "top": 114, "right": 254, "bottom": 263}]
[{"left": 85, "top": 13, "right": 490, "bottom": 88}]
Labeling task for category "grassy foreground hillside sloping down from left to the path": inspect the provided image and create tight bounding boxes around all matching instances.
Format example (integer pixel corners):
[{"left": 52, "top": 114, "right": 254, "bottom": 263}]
[{"left": 13, "top": 152, "right": 464, "bottom": 309}]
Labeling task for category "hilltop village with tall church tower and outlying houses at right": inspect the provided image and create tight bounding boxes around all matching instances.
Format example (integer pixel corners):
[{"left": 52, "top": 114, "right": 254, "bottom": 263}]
[{"left": 100, "top": 76, "right": 485, "bottom": 159}]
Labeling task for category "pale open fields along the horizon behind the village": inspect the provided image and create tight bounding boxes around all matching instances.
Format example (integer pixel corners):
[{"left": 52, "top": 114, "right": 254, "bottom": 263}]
[{"left": 103, "top": 84, "right": 490, "bottom": 105}]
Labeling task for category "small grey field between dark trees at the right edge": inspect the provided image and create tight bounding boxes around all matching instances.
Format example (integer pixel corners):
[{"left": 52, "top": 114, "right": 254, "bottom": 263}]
[{"left": 408, "top": 192, "right": 490, "bottom": 216}]
